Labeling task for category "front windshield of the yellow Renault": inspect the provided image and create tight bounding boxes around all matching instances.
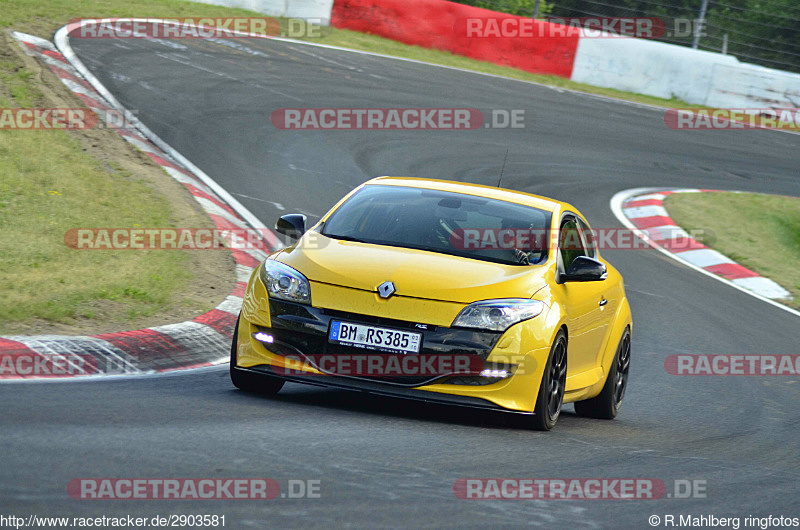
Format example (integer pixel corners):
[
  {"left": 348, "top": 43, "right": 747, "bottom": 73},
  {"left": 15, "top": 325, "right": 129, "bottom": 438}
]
[{"left": 321, "top": 185, "right": 551, "bottom": 265}]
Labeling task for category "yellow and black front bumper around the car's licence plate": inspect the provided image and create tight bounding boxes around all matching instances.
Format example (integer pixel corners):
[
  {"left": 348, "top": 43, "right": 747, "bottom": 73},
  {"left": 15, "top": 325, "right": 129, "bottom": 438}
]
[{"left": 236, "top": 274, "right": 552, "bottom": 414}]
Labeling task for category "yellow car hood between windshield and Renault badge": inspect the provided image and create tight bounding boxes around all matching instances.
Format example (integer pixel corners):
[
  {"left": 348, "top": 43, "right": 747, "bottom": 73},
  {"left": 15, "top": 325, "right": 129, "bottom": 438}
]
[{"left": 275, "top": 233, "right": 547, "bottom": 304}]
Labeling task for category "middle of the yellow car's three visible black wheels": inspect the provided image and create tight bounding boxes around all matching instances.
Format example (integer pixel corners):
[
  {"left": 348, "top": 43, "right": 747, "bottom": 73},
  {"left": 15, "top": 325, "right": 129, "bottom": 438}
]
[{"left": 530, "top": 329, "right": 567, "bottom": 431}]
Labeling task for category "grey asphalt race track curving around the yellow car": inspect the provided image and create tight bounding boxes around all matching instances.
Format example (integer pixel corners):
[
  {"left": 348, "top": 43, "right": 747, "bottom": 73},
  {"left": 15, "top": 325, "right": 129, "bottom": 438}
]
[{"left": 0, "top": 35, "right": 800, "bottom": 528}]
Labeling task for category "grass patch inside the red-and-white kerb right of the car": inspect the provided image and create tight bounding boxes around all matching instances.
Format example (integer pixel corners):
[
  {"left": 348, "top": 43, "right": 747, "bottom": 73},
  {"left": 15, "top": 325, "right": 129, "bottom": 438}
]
[{"left": 665, "top": 192, "right": 800, "bottom": 307}]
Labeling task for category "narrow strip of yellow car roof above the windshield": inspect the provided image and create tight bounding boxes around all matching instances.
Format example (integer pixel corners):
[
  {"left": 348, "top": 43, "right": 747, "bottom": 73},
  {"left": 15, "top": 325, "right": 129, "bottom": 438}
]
[{"left": 364, "top": 177, "right": 577, "bottom": 212}]
